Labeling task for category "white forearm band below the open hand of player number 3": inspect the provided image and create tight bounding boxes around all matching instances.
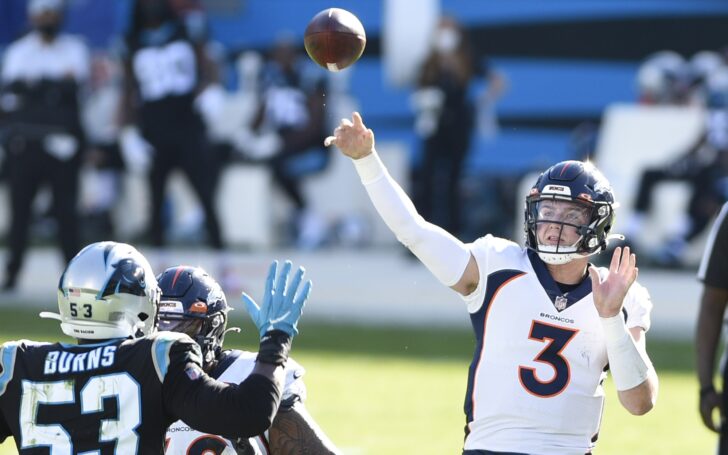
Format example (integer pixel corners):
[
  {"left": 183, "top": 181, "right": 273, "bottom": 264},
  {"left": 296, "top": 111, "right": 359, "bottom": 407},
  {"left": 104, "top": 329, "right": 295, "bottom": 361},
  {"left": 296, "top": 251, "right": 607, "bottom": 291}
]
[{"left": 599, "top": 313, "right": 652, "bottom": 391}]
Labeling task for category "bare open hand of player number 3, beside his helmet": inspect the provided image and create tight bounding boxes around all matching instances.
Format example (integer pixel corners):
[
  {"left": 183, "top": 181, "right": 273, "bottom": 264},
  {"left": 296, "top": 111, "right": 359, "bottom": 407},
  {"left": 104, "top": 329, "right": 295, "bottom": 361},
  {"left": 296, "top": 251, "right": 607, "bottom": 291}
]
[{"left": 589, "top": 247, "right": 638, "bottom": 318}]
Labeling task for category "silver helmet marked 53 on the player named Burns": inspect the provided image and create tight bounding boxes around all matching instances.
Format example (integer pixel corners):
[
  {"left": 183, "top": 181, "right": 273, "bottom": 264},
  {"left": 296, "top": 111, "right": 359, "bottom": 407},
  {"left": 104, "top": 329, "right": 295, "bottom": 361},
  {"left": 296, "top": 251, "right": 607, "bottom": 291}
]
[{"left": 41, "top": 242, "right": 161, "bottom": 340}]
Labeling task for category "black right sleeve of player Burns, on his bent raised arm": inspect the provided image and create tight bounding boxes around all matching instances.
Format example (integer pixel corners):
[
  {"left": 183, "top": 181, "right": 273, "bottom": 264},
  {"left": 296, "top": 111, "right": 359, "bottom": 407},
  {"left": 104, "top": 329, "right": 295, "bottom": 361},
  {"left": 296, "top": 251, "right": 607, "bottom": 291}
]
[{"left": 162, "top": 338, "right": 281, "bottom": 439}]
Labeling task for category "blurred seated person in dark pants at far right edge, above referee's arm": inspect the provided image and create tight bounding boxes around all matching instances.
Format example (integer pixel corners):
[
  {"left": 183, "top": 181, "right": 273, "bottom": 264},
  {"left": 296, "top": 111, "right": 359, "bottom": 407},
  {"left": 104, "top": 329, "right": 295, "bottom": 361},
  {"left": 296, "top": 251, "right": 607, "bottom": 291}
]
[{"left": 625, "top": 66, "right": 728, "bottom": 266}]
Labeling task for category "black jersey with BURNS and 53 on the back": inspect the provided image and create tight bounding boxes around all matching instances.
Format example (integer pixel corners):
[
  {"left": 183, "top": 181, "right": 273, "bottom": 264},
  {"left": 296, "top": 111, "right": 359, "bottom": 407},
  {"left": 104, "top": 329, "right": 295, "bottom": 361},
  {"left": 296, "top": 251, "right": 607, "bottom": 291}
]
[{"left": 0, "top": 332, "right": 279, "bottom": 455}]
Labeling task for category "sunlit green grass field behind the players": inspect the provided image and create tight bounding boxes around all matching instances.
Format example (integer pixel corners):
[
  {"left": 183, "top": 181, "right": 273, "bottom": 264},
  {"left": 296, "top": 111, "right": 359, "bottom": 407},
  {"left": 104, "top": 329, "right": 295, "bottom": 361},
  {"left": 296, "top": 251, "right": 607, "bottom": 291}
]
[{"left": 0, "top": 309, "right": 715, "bottom": 455}]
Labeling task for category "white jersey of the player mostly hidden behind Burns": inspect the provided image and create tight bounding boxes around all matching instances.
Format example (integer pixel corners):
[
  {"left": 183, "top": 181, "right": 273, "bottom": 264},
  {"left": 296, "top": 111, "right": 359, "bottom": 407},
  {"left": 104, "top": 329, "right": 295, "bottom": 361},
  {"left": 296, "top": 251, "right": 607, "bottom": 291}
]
[{"left": 164, "top": 350, "right": 306, "bottom": 455}]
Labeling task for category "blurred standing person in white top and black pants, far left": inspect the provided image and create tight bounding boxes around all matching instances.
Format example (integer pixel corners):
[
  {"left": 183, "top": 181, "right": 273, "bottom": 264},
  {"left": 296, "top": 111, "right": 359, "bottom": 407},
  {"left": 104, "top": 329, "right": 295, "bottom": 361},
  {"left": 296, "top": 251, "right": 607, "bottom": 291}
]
[{"left": 0, "top": 0, "right": 90, "bottom": 290}]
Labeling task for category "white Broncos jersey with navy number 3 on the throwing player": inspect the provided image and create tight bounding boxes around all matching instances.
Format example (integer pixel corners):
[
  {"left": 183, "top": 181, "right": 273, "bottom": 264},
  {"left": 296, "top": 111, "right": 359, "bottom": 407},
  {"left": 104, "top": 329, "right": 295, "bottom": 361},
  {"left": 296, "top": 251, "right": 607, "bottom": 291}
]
[{"left": 464, "top": 235, "right": 652, "bottom": 455}]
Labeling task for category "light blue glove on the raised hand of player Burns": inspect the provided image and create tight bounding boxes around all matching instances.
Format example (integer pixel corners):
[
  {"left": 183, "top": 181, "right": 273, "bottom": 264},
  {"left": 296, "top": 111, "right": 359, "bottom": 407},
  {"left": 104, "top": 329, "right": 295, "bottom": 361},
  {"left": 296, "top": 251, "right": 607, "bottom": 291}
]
[{"left": 243, "top": 261, "right": 312, "bottom": 338}]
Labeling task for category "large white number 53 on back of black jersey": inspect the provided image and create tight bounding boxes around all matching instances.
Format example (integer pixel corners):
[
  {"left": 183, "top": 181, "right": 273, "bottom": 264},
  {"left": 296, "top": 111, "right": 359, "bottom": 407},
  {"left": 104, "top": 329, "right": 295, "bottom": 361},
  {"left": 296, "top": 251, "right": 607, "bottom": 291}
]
[{"left": 20, "top": 373, "right": 141, "bottom": 455}]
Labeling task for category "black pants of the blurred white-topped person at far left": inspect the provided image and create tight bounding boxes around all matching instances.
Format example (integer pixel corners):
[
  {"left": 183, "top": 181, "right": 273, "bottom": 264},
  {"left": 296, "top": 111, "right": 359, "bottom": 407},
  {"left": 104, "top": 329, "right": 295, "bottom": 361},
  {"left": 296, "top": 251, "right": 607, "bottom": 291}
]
[{"left": 5, "top": 137, "right": 80, "bottom": 287}]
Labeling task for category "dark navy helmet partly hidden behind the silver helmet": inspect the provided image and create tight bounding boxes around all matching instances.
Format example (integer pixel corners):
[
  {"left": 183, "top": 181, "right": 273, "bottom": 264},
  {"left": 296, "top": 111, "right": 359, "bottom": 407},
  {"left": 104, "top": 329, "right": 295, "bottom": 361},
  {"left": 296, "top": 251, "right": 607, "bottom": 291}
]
[{"left": 157, "top": 265, "right": 232, "bottom": 365}]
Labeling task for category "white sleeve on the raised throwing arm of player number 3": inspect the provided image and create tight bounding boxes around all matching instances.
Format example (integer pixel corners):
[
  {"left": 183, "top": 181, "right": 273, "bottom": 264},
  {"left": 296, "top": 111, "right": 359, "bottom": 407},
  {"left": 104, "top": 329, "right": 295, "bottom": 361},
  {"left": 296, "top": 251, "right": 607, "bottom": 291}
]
[{"left": 353, "top": 150, "right": 470, "bottom": 286}]
